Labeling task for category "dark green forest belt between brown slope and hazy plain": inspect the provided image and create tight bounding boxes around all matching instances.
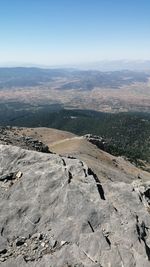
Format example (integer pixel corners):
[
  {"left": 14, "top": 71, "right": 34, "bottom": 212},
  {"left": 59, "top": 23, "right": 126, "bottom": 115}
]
[{"left": 0, "top": 102, "right": 150, "bottom": 164}]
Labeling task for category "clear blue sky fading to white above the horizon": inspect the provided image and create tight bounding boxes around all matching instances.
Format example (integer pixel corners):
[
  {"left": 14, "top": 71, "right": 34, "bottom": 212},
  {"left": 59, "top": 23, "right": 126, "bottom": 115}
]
[{"left": 0, "top": 0, "right": 150, "bottom": 65}]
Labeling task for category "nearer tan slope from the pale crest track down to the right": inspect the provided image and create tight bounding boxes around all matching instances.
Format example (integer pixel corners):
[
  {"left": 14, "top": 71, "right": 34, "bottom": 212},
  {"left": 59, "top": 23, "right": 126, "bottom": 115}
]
[{"left": 49, "top": 137, "right": 150, "bottom": 182}]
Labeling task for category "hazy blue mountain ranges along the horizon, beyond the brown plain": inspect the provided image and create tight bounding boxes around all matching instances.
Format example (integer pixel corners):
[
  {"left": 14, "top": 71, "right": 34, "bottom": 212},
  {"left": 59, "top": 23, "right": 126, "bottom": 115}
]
[{"left": 0, "top": 67, "right": 150, "bottom": 90}]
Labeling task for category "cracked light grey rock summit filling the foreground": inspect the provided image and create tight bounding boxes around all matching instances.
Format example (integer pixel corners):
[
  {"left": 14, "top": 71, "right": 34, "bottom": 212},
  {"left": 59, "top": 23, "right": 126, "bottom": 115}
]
[{"left": 0, "top": 140, "right": 150, "bottom": 267}]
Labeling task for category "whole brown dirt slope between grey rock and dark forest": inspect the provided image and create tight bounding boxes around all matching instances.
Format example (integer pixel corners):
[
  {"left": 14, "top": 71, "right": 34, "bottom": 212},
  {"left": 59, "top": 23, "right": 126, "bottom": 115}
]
[{"left": 0, "top": 127, "right": 150, "bottom": 182}]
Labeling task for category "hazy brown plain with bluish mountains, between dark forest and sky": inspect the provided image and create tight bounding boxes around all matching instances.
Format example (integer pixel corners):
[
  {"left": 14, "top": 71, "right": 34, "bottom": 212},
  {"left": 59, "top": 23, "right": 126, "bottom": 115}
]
[{"left": 0, "top": 68, "right": 150, "bottom": 113}]
